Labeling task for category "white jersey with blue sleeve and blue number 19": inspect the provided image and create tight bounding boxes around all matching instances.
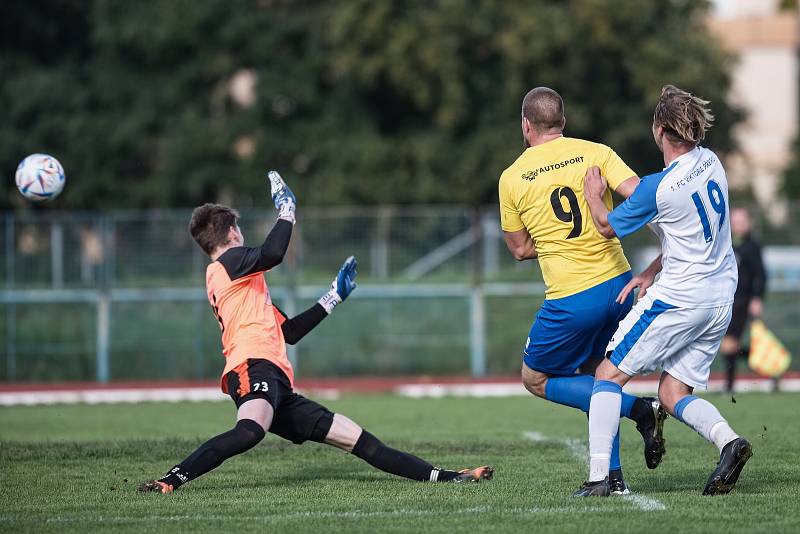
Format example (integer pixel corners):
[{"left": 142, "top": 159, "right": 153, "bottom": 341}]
[{"left": 608, "top": 147, "right": 739, "bottom": 308}]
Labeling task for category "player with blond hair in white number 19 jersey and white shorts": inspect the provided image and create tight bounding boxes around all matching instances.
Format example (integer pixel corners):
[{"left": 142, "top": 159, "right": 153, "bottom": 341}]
[{"left": 575, "top": 85, "right": 753, "bottom": 496}]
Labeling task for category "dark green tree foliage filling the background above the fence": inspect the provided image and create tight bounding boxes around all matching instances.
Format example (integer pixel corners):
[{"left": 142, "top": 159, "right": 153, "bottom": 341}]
[{"left": 0, "top": 0, "right": 740, "bottom": 208}]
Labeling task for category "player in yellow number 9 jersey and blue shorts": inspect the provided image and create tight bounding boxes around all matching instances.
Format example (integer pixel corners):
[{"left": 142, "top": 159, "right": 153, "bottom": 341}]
[{"left": 499, "top": 87, "right": 666, "bottom": 494}]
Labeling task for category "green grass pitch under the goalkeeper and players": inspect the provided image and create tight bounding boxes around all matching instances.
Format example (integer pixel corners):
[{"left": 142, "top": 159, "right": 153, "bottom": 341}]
[{"left": 0, "top": 394, "right": 800, "bottom": 534}]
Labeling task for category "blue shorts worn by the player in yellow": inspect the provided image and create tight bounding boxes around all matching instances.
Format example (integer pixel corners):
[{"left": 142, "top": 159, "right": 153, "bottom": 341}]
[{"left": 522, "top": 271, "right": 633, "bottom": 375}]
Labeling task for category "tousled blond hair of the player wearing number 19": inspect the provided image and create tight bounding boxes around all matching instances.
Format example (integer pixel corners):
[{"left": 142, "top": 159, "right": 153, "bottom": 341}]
[{"left": 653, "top": 85, "right": 714, "bottom": 146}]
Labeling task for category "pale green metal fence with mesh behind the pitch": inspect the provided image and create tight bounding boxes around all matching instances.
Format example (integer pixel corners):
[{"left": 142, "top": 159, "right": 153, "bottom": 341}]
[{"left": 0, "top": 206, "right": 800, "bottom": 382}]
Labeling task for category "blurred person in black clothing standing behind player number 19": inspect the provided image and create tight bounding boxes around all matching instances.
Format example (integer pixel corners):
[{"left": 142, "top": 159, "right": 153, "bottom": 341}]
[{"left": 720, "top": 208, "right": 767, "bottom": 391}]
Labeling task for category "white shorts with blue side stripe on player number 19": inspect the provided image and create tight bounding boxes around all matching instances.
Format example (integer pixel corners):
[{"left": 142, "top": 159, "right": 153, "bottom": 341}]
[{"left": 606, "top": 295, "right": 733, "bottom": 389}]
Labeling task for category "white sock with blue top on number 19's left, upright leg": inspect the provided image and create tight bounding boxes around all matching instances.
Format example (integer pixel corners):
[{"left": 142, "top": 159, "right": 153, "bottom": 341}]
[{"left": 589, "top": 380, "right": 622, "bottom": 482}]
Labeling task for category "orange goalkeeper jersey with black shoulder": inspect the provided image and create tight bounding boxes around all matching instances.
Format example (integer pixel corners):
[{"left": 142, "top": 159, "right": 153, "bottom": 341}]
[{"left": 206, "top": 247, "right": 294, "bottom": 393}]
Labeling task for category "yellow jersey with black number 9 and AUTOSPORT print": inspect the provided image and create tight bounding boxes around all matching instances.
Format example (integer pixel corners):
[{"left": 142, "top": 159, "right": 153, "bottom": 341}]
[{"left": 499, "top": 137, "right": 636, "bottom": 299}]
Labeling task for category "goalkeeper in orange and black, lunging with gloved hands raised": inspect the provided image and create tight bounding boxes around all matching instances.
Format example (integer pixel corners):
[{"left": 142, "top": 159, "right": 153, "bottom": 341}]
[{"left": 139, "top": 171, "right": 493, "bottom": 493}]
